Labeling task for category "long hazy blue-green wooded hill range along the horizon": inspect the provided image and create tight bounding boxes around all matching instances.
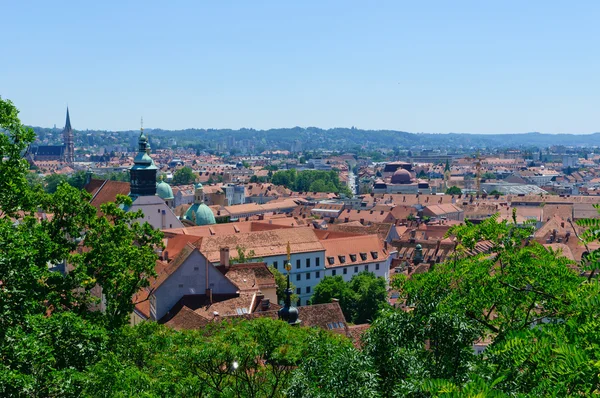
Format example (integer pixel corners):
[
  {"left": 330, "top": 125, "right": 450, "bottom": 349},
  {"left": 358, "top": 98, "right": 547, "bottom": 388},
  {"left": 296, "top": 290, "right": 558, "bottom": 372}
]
[{"left": 34, "top": 127, "right": 600, "bottom": 150}]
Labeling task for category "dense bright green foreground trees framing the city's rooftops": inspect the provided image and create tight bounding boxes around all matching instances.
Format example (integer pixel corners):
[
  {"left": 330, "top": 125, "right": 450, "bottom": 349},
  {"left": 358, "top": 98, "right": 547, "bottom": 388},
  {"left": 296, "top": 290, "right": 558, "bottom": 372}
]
[{"left": 0, "top": 99, "right": 600, "bottom": 397}]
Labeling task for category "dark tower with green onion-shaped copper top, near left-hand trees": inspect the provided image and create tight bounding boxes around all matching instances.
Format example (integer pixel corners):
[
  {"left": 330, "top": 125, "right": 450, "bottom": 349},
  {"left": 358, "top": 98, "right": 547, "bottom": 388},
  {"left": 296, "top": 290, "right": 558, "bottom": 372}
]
[{"left": 129, "top": 123, "right": 158, "bottom": 197}]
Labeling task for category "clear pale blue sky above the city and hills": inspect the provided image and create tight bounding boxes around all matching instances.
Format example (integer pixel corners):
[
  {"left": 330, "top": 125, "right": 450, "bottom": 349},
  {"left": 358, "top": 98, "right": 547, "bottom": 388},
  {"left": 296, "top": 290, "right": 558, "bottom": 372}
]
[{"left": 0, "top": 0, "right": 600, "bottom": 133}]
